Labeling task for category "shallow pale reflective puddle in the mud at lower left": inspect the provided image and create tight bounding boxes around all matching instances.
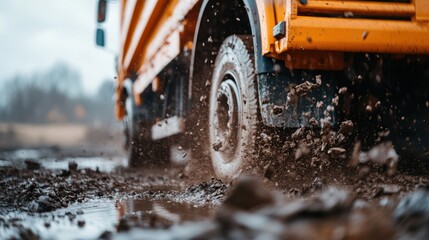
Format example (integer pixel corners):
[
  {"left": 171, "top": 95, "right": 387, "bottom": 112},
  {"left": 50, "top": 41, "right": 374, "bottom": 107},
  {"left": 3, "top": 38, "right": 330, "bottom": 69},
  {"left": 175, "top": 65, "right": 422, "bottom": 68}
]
[{"left": 0, "top": 199, "right": 214, "bottom": 239}]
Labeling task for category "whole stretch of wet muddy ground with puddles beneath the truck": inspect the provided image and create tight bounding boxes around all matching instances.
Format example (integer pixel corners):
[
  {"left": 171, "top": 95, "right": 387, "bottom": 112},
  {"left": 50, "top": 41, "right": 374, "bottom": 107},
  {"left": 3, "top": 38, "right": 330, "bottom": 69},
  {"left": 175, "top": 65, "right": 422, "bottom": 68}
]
[{"left": 0, "top": 145, "right": 429, "bottom": 239}]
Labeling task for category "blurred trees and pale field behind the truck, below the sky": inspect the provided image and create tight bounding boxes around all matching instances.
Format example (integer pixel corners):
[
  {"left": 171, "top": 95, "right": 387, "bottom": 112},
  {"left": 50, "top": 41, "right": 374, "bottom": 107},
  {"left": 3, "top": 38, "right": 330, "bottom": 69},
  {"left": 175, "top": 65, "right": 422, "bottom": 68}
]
[{"left": 0, "top": 63, "right": 122, "bottom": 149}]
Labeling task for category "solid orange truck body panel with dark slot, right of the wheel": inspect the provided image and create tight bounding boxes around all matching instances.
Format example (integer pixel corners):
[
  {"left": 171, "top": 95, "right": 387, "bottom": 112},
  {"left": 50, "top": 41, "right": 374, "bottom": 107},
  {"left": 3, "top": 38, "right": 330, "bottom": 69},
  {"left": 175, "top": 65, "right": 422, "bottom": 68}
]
[{"left": 275, "top": 0, "right": 429, "bottom": 55}]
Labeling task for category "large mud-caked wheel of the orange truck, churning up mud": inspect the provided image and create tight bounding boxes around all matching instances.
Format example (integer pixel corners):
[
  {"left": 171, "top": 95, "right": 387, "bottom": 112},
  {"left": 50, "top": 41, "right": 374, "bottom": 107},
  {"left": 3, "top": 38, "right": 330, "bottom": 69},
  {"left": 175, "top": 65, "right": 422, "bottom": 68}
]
[{"left": 208, "top": 35, "right": 260, "bottom": 181}]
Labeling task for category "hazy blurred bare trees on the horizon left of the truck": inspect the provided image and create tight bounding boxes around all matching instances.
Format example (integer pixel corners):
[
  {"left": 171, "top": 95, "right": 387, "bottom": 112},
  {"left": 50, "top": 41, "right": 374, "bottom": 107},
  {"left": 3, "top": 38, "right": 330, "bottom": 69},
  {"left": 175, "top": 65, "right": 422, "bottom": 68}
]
[{"left": 0, "top": 63, "right": 114, "bottom": 124}]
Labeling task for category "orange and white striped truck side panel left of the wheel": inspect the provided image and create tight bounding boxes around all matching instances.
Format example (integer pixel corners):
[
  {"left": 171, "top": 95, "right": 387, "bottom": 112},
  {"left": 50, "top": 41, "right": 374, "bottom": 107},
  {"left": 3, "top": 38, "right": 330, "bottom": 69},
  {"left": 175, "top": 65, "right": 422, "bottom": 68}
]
[{"left": 116, "top": 0, "right": 198, "bottom": 119}]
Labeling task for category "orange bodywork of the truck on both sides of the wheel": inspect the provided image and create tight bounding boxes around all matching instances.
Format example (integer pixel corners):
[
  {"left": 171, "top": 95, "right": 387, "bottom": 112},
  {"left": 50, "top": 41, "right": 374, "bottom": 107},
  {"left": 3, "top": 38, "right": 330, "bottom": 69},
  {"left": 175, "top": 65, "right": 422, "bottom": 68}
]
[{"left": 116, "top": 0, "right": 429, "bottom": 119}]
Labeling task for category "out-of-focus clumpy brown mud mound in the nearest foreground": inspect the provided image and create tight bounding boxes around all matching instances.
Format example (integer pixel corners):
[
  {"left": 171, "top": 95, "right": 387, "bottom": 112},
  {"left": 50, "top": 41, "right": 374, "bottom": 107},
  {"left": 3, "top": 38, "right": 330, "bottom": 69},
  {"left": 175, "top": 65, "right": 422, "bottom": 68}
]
[{"left": 111, "top": 179, "right": 429, "bottom": 239}]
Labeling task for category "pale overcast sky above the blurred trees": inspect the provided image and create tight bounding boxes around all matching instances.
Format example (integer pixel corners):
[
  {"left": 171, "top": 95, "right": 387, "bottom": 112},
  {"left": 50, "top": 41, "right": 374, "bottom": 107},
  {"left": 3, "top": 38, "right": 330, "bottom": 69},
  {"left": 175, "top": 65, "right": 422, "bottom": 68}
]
[{"left": 0, "top": 0, "right": 119, "bottom": 94}]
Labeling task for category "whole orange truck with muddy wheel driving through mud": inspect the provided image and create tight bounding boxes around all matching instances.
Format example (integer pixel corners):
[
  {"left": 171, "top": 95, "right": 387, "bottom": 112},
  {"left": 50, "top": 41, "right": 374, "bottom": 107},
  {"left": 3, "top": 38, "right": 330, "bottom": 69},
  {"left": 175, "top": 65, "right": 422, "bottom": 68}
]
[{"left": 97, "top": 0, "right": 429, "bottom": 179}]
